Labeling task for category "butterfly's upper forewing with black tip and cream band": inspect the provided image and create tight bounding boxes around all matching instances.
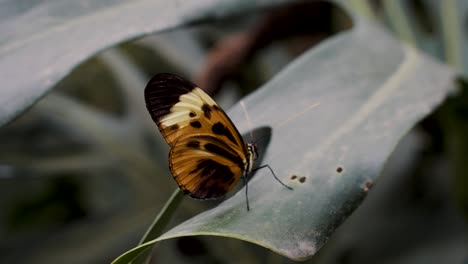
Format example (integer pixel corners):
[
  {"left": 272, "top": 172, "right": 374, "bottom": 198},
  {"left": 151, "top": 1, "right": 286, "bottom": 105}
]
[{"left": 145, "top": 73, "right": 246, "bottom": 151}]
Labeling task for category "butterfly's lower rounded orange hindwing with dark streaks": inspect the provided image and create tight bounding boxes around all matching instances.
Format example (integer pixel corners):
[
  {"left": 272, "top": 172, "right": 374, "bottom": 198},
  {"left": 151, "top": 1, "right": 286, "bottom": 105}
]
[{"left": 169, "top": 133, "right": 245, "bottom": 199}]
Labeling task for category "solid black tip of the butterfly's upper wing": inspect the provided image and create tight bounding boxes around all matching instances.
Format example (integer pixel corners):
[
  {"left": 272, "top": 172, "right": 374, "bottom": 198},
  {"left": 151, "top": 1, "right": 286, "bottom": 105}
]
[{"left": 145, "top": 73, "right": 196, "bottom": 124}]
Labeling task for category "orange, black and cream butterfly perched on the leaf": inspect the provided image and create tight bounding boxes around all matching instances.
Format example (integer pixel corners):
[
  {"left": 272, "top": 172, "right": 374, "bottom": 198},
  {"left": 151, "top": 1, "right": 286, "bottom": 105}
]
[{"left": 145, "top": 73, "right": 292, "bottom": 210}]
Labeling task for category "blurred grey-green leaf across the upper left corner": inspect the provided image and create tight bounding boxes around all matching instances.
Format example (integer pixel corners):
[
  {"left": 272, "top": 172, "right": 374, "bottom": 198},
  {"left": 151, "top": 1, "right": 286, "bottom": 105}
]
[{"left": 0, "top": 0, "right": 298, "bottom": 125}]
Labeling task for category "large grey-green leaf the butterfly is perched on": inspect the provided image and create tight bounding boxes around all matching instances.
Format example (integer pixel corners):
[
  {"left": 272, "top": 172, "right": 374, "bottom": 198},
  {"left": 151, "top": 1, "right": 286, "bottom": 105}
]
[{"left": 112, "top": 18, "right": 454, "bottom": 263}]
